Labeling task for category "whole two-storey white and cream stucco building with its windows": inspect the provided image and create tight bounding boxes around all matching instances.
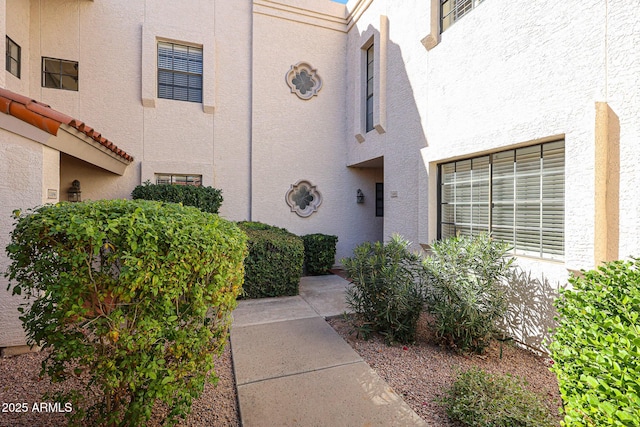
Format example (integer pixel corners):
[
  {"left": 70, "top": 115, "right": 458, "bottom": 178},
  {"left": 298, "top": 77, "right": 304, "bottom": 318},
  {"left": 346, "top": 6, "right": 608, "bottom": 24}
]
[{"left": 0, "top": 0, "right": 640, "bottom": 347}]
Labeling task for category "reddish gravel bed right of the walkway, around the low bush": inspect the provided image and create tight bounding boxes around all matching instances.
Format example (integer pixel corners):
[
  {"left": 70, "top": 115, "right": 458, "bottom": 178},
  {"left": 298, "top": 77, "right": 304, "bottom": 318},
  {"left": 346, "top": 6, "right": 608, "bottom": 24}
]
[{"left": 329, "top": 315, "right": 562, "bottom": 427}]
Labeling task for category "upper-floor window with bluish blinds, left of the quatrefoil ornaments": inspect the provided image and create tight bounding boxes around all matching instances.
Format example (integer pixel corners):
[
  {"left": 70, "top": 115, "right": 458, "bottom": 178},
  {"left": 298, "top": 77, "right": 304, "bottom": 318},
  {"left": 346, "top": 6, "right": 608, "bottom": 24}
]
[{"left": 158, "top": 42, "right": 202, "bottom": 102}]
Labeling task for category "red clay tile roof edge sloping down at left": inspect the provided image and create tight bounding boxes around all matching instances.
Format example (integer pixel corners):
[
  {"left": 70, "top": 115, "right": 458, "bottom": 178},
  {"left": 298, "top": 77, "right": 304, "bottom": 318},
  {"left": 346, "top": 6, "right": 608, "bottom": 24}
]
[{"left": 0, "top": 88, "right": 133, "bottom": 162}]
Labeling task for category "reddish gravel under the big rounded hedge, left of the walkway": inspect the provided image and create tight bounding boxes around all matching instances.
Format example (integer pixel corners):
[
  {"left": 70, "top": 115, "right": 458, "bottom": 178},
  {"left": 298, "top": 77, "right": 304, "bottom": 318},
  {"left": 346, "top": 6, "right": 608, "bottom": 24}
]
[{"left": 0, "top": 343, "right": 240, "bottom": 427}]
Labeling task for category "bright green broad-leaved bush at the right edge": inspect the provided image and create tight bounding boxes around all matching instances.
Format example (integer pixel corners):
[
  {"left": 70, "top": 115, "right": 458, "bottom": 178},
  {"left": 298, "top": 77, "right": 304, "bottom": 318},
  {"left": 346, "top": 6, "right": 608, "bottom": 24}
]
[{"left": 550, "top": 259, "right": 640, "bottom": 426}]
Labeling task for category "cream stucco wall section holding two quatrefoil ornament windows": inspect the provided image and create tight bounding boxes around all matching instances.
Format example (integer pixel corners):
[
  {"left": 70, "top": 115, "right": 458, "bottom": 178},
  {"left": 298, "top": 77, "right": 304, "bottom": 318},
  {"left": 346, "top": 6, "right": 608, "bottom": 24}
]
[{"left": 252, "top": 2, "right": 380, "bottom": 259}]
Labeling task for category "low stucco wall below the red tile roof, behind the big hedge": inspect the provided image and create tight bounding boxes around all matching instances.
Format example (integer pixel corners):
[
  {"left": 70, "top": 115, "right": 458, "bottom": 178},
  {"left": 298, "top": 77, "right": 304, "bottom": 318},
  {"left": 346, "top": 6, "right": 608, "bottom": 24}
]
[{"left": 0, "top": 129, "right": 45, "bottom": 346}]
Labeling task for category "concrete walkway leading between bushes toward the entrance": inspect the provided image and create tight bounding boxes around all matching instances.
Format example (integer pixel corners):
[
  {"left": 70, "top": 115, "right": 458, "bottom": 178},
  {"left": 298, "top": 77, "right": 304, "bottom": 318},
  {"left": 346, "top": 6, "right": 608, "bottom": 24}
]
[{"left": 231, "top": 275, "right": 426, "bottom": 427}]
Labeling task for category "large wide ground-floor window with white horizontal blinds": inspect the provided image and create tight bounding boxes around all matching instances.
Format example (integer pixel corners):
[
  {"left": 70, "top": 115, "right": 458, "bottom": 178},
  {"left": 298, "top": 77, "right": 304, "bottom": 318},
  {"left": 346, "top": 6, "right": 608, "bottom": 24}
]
[{"left": 438, "top": 141, "right": 564, "bottom": 259}]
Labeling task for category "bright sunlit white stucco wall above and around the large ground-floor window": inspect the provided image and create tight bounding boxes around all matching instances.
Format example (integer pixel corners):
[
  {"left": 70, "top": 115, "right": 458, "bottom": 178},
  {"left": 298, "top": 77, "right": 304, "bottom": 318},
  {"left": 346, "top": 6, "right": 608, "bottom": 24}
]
[{"left": 423, "top": 0, "right": 605, "bottom": 278}]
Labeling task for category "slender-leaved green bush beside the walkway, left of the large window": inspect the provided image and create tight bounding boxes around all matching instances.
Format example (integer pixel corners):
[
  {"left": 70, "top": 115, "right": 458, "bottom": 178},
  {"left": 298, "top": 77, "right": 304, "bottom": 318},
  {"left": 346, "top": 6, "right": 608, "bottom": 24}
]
[{"left": 342, "top": 235, "right": 426, "bottom": 343}]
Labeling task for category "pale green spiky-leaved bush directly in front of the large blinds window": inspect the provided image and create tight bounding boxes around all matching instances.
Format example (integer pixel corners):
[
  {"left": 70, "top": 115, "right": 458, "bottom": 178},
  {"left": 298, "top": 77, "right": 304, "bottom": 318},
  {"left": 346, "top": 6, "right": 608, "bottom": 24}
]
[{"left": 427, "top": 235, "right": 513, "bottom": 352}]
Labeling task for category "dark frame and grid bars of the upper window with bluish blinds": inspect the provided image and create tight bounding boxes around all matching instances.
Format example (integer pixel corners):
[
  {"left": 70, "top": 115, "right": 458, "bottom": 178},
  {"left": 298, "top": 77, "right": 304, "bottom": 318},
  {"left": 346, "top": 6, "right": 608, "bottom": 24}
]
[{"left": 156, "top": 40, "right": 204, "bottom": 104}]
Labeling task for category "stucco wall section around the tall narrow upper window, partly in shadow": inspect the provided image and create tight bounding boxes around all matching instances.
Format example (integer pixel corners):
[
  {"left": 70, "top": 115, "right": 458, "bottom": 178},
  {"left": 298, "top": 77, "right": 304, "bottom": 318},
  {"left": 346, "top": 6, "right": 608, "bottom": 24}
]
[{"left": 345, "top": 1, "right": 429, "bottom": 252}]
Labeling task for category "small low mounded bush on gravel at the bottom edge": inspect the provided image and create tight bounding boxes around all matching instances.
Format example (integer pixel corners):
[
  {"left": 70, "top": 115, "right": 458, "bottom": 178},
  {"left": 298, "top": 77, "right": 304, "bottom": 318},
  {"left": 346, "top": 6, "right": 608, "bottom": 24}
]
[{"left": 442, "top": 368, "right": 555, "bottom": 427}]
